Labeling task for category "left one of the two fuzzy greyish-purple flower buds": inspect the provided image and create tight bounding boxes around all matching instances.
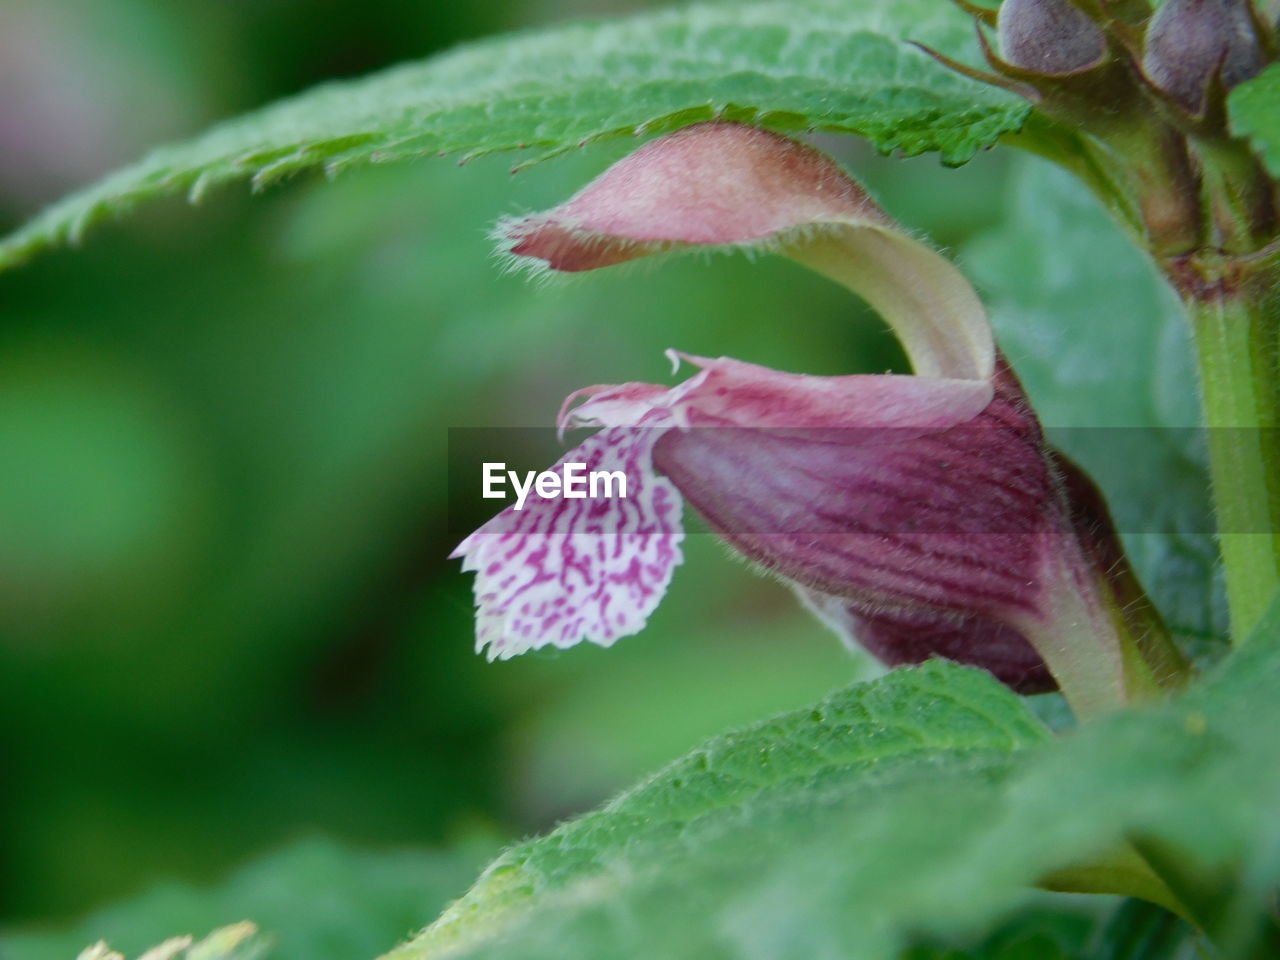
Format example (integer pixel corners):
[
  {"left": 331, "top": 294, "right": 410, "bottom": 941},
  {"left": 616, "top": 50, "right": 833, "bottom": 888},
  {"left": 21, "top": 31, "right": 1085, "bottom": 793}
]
[{"left": 997, "top": 0, "right": 1106, "bottom": 76}]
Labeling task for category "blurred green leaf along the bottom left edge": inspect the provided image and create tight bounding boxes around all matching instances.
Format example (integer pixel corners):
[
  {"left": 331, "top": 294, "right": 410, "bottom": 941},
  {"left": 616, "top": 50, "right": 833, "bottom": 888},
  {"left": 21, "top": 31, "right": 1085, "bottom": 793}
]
[{"left": 0, "top": 840, "right": 490, "bottom": 960}]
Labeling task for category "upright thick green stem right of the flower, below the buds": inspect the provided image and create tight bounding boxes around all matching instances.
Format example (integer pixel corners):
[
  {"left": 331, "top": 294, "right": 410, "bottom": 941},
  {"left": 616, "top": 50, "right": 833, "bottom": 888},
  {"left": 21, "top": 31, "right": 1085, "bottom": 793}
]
[{"left": 1176, "top": 262, "right": 1280, "bottom": 643}]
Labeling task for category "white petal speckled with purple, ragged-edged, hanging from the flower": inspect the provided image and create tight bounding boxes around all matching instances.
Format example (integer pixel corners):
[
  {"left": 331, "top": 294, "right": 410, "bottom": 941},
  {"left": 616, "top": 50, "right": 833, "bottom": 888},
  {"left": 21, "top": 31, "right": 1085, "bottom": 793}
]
[{"left": 451, "top": 426, "right": 684, "bottom": 659}]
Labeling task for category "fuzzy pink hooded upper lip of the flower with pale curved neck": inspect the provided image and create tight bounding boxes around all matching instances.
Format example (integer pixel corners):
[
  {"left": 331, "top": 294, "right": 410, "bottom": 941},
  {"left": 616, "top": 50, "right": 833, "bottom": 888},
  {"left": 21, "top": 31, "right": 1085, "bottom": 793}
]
[{"left": 495, "top": 123, "right": 995, "bottom": 380}]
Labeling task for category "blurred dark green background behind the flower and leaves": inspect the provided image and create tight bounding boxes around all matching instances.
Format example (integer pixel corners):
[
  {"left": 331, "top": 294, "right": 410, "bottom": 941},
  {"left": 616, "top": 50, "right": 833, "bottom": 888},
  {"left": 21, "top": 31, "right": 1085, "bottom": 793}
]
[{"left": 0, "top": 0, "right": 1007, "bottom": 960}]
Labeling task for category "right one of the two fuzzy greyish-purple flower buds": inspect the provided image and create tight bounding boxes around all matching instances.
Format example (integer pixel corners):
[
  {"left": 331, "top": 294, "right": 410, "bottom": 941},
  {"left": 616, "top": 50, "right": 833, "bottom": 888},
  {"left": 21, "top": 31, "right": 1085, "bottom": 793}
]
[{"left": 1142, "top": 0, "right": 1265, "bottom": 116}]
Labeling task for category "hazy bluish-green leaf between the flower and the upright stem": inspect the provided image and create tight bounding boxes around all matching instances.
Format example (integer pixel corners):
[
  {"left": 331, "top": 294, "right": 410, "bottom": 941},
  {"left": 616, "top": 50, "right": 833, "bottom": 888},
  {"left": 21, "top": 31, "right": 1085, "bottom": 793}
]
[{"left": 961, "top": 157, "right": 1226, "bottom": 649}]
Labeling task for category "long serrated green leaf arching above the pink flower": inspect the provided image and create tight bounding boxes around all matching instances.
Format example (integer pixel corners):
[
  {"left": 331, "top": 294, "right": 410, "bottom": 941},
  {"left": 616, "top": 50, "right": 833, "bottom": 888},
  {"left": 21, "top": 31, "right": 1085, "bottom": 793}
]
[{"left": 0, "top": 0, "right": 1029, "bottom": 268}]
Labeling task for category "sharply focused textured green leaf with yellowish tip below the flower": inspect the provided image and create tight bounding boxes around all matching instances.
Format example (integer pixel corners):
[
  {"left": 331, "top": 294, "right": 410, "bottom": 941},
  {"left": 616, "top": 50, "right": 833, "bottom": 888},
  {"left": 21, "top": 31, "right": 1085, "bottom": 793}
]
[{"left": 378, "top": 662, "right": 1047, "bottom": 960}]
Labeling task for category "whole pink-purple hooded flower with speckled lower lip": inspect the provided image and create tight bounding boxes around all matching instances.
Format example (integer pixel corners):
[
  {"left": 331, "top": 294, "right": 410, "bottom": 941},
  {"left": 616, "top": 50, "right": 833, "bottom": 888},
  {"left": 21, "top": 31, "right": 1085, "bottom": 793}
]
[{"left": 453, "top": 124, "right": 1176, "bottom": 710}]
